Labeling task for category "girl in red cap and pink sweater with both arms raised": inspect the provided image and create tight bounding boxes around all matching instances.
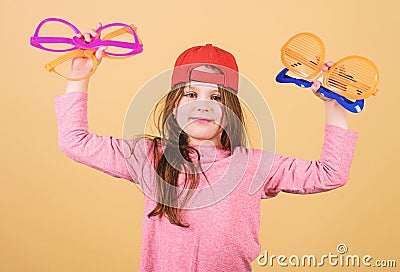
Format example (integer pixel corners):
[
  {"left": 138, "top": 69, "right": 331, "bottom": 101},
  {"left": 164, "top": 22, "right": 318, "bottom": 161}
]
[{"left": 54, "top": 26, "right": 358, "bottom": 271}]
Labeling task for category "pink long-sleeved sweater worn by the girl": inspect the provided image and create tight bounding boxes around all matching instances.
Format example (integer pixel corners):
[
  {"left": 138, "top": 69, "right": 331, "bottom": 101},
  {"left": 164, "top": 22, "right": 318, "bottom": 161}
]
[{"left": 54, "top": 92, "right": 358, "bottom": 271}]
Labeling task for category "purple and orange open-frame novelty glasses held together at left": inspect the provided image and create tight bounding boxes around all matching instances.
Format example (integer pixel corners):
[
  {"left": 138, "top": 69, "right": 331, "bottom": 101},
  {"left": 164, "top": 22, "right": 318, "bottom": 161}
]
[{"left": 30, "top": 18, "right": 143, "bottom": 80}]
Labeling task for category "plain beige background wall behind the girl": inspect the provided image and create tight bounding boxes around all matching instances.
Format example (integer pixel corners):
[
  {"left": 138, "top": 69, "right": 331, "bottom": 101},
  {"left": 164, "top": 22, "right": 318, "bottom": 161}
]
[{"left": 0, "top": 0, "right": 400, "bottom": 272}]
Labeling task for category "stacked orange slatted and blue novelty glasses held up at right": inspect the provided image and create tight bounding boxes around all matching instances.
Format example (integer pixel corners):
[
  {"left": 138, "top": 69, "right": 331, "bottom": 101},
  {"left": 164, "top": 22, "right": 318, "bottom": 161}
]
[{"left": 276, "top": 33, "right": 378, "bottom": 113}]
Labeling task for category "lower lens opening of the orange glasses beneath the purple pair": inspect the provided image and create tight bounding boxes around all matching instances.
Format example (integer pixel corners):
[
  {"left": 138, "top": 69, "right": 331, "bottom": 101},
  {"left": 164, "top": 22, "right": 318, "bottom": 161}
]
[{"left": 49, "top": 57, "right": 93, "bottom": 80}]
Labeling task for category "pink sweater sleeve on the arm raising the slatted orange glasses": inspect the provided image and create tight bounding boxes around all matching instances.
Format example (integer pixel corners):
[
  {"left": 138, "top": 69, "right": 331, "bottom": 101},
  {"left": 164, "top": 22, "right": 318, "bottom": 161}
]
[{"left": 261, "top": 125, "right": 358, "bottom": 198}]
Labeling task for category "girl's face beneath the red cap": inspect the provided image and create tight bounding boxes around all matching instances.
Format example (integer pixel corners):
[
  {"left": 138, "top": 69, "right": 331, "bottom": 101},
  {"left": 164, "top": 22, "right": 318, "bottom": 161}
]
[{"left": 174, "top": 81, "right": 225, "bottom": 145}]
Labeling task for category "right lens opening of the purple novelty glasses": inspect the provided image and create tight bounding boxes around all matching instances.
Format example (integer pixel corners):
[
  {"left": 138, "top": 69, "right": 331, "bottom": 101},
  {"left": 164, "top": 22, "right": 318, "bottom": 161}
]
[{"left": 101, "top": 26, "right": 140, "bottom": 57}]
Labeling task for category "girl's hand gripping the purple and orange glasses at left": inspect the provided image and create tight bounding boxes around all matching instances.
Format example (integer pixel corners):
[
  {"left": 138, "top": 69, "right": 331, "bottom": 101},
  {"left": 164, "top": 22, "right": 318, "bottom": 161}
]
[{"left": 71, "top": 23, "right": 107, "bottom": 77}]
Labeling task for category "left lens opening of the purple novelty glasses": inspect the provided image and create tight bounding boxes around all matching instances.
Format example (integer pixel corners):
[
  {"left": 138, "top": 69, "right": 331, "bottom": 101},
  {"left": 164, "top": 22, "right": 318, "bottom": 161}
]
[{"left": 38, "top": 21, "right": 76, "bottom": 52}]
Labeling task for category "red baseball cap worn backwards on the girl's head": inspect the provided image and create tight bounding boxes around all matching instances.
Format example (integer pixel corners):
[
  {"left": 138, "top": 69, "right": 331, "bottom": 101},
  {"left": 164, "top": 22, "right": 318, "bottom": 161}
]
[{"left": 171, "top": 44, "right": 239, "bottom": 94}]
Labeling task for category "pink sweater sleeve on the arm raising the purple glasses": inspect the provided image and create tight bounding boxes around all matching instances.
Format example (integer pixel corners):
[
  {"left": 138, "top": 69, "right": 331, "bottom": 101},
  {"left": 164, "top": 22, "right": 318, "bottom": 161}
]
[{"left": 54, "top": 92, "right": 148, "bottom": 183}]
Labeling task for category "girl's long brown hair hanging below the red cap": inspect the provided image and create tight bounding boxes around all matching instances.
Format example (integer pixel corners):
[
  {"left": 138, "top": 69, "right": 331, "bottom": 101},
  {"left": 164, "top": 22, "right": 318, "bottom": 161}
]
[{"left": 134, "top": 82, "right": 246, "bottom": 227}]
